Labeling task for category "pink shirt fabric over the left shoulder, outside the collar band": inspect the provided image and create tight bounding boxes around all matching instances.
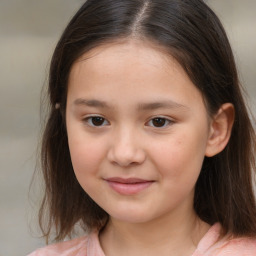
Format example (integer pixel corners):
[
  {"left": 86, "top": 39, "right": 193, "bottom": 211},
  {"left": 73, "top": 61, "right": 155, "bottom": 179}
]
[{"left": 28, "top": 236, "right": 90, "bottom": 256}]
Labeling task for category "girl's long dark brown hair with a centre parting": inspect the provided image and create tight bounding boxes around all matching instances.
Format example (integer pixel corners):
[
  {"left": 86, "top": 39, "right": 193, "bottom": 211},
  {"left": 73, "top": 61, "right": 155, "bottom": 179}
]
[{"left": 39, "top": 0, "right": 256, "bottom": 241}]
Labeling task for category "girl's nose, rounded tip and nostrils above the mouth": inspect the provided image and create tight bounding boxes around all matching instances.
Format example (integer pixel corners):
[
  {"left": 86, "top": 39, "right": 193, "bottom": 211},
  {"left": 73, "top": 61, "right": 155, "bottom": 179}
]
[{"left": 108, "top": 129, "right": 146, "bottom": 167}]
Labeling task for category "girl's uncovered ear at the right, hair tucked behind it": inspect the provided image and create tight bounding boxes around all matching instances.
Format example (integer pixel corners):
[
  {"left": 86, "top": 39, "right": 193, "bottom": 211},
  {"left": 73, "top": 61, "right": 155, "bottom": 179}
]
[{"left": 205, "top": 103, "right": 235, "bottom": 157}]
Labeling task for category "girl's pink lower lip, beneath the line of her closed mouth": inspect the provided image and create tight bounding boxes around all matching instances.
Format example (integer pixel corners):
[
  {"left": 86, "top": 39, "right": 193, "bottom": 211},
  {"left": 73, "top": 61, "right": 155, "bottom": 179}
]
[{"left": 107, "top": 181, "right": 153, "bottom": 195}]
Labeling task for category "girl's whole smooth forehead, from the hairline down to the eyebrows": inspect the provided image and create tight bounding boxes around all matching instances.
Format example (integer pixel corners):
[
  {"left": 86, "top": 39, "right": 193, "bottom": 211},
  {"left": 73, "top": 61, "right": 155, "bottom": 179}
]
[{"left": 68, "top": 40, "right": 205, "bottom": 110}]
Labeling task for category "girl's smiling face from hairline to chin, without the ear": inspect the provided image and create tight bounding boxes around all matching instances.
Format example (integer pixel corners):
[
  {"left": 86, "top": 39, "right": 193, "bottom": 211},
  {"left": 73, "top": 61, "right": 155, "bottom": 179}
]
[{"left": 66, "top": 41, "right": 210, "bottom": 223}]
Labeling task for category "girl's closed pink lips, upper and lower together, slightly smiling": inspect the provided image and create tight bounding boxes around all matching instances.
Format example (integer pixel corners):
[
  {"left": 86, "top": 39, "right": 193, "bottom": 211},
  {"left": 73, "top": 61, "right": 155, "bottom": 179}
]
[{"left": 105, "top": 177, "right": 154, "bottom": 195}]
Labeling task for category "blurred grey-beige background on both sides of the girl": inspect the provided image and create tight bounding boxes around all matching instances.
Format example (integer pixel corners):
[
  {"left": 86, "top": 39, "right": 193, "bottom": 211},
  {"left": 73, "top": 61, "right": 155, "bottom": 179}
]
[{"left": 0, "top": 0, "right": 256, "bottom": 256}]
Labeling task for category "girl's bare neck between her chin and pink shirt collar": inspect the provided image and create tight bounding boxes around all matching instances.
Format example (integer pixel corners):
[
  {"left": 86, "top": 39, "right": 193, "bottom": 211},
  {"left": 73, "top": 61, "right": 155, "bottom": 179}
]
[{"left": 100, "top": 212, "right": 209, "bottom": 256}]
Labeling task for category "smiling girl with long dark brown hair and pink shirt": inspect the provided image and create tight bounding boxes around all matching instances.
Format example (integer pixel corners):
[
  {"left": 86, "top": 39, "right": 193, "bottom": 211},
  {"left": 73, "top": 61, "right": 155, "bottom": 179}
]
[{"left": 28, "top": 0, "right": 256, "bottom": 256}]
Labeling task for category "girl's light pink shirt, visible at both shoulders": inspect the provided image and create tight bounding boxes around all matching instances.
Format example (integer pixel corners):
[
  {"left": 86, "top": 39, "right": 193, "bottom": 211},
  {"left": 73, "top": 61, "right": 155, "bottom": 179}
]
[{"left": 28, "top": 223, "right": 256, "bottom": 256}]
